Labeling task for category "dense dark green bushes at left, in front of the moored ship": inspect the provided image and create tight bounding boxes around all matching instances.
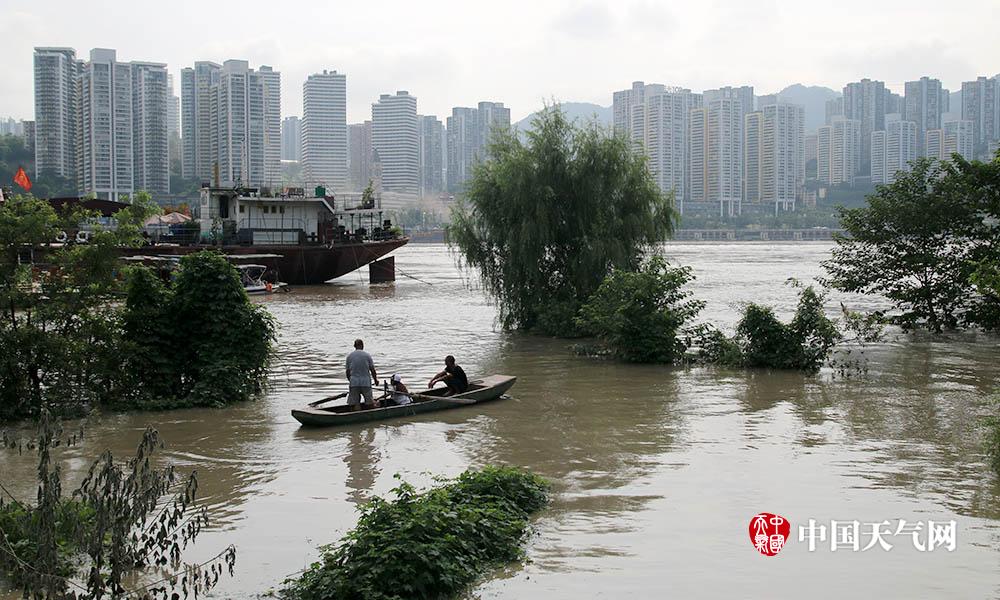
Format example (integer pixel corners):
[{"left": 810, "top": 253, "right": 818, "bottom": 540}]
[{"left": 0, "top": 193, "right": 274, "bottom": 421}]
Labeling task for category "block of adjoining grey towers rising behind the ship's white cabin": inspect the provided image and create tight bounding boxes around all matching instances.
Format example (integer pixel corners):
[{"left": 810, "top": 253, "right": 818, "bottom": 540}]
[{"left": 181, "top": 60, "right": 281, "bottom": 186}]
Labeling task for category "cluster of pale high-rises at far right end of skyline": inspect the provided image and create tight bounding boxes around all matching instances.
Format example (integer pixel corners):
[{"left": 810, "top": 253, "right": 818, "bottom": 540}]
[{"left": 816, "top": 76, "right": 1000, "bottom": 185}]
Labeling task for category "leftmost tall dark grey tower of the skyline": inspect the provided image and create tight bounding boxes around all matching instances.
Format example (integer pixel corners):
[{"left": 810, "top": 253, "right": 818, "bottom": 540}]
[{"left": 34, "top": 47, "right": 82, "bottom": 180}]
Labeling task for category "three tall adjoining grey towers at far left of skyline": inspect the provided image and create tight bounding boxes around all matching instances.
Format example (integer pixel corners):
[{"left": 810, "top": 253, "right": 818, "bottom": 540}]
[{"left": 34, "top": 48, "right": 176, "bottom": 199}]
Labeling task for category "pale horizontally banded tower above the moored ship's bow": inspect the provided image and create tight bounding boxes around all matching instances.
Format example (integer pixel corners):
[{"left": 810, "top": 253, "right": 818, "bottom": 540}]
[{"left": 372, "top": 91, "right": 420, "bottom": 194}]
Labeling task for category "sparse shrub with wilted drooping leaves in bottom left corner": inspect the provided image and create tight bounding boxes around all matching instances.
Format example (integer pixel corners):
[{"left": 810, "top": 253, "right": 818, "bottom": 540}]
[{"left": 0, "top": 413, "right": 236, "bottom": 600}]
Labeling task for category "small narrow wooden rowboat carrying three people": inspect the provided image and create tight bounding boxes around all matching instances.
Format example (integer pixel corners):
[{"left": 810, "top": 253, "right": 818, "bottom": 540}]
[{"left": 292, "top": 375, "right": 517, "bottom": 427}]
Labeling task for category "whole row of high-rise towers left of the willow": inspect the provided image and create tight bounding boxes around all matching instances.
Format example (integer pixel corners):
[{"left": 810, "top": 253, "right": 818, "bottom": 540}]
[{"left": 35, "top": 48, "right": 510, "bottom": 199}]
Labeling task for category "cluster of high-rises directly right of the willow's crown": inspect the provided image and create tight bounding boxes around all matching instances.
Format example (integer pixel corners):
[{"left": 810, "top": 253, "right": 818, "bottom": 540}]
[{"left": 612, "top": 81, "right": 805, "bottom": 215}]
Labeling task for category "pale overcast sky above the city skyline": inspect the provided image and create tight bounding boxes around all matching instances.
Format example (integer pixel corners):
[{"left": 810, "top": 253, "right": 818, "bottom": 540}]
[{"left": 0, "top": 0, "right": 1000, "bottom": 122}]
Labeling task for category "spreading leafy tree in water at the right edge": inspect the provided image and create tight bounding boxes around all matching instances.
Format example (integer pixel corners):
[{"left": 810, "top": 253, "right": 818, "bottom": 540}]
[{"left": 823, "top": 159, "right": 997, "bottom": 332}]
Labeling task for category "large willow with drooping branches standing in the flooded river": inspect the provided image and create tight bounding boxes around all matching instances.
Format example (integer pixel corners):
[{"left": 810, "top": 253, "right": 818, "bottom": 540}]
[{"left": 448, "top": 106, "right": 676, "bottom": 335}]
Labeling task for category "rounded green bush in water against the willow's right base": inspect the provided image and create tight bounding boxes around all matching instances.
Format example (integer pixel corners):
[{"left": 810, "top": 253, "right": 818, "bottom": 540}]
[{"left": 577, "top": 256, "right": 705, "bottom": 363}]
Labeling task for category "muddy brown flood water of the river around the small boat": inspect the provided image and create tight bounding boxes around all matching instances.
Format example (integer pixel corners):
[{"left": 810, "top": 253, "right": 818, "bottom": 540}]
[{"left": 0, "top": 243, "right": 1000, "bottom": 600}]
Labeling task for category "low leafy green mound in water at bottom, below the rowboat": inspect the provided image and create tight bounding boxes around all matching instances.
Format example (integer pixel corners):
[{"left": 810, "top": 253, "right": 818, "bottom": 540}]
[{"left": 284, "top": 467, "right": 548, "bottom": 600}]
